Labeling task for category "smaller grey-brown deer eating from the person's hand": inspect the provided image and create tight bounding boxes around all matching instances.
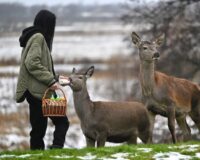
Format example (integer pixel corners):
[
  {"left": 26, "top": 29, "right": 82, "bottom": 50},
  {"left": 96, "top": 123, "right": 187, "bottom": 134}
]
[{"left": 68, "top": 66, "right": 150, "bottom": 147}]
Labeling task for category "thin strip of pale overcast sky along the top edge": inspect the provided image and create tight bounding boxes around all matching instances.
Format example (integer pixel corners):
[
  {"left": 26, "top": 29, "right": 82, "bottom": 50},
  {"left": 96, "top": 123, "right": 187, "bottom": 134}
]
[{"left": 0, "top": 0, "right": 128, "bottom": 6}]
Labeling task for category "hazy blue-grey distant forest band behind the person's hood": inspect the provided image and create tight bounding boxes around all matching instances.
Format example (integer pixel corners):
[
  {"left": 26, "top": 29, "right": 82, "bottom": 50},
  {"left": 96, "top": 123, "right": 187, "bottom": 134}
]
[{"left": 0, "top": 3, "right": 123, "bottom": 32}]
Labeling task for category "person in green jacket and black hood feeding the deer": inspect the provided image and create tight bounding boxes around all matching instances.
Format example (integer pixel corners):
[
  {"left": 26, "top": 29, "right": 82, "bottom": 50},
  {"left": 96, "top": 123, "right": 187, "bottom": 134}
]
[{"left": 16, "top": 10, "right": 69, "bottom": 150}]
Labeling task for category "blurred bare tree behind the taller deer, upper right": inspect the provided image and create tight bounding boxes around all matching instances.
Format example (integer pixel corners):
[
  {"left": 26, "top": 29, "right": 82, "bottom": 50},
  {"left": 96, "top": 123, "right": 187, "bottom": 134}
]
[{"left": 122, "top": 0, "right": 200, "bottom": 83}]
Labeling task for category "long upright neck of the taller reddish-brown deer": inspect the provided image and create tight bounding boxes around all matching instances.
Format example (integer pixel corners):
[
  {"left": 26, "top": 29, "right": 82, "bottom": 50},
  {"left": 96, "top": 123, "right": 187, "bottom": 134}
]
[{"left": 140, "top": 61, "right": 155, "bottom": 97}]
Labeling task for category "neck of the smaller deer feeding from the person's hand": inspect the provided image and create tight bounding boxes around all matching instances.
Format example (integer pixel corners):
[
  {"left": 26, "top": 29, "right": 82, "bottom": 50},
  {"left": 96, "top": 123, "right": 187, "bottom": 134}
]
[{"left": 73, "top": 86, "right": 93, "bottom": 121}]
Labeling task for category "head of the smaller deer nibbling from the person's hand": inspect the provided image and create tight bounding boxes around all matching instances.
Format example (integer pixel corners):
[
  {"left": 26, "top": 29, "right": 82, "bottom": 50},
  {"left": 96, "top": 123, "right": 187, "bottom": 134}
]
[{"left": 69, "top": 66, "right": 94, "bottom": 92}]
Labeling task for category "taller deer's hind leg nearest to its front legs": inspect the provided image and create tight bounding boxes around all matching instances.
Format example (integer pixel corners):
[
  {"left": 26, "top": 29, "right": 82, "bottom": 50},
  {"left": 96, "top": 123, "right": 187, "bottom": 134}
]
[{"left": 176, "top": 114, "right": 191, "bottom": 141}]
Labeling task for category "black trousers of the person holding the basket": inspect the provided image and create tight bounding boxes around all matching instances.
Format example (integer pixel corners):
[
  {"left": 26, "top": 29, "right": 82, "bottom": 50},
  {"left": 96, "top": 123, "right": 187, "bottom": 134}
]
[{"left": 26, "top": 93, "right": 69, "bottom": 150}]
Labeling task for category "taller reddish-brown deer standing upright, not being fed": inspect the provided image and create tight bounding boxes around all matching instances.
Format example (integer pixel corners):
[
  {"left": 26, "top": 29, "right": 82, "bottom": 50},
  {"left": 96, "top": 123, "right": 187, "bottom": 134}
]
[{"left": 132, "top": 32, "right": 200, "bottom": 143}]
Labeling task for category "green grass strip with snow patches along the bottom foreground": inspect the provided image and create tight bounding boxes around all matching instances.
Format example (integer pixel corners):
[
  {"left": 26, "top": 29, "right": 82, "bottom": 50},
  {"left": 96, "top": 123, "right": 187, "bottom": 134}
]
[{"left": 0, "top": 142, "right": 200, "bottom": 160}]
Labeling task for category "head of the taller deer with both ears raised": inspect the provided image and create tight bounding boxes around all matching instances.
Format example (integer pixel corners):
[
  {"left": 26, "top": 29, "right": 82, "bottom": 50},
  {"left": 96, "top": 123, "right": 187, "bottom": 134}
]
[{"left": 131, "top": 32, "right": 164, "bottom": 62}]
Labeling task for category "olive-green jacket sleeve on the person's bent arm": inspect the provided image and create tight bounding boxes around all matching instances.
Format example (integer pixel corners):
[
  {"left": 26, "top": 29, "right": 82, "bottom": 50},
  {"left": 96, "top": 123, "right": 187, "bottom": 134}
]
[{"left": 24, "top": 35, "right": 56, "bottom": 86}]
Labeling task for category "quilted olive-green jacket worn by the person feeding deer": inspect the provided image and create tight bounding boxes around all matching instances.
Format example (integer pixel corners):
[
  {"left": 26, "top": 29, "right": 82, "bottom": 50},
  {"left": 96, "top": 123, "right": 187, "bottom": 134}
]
[{"left": 16, "top": 33, "right": 56, "bottom": 102}]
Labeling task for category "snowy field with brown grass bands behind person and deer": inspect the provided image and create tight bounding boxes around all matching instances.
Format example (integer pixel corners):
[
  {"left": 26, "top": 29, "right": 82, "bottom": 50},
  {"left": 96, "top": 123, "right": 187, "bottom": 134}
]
[{"left": 0, "top": 23, "right": 200, "bottom": 151}]
